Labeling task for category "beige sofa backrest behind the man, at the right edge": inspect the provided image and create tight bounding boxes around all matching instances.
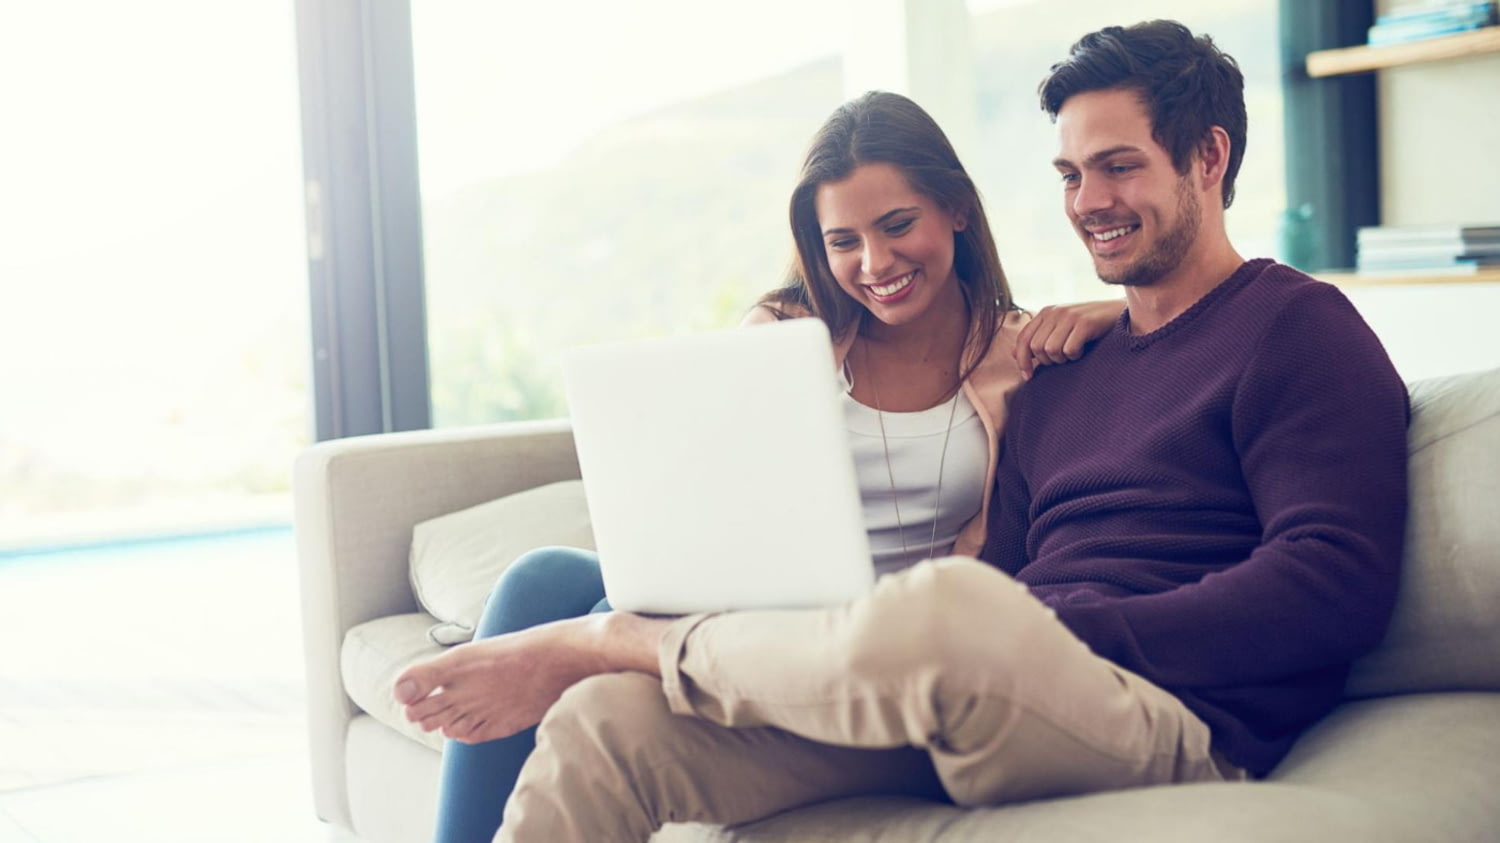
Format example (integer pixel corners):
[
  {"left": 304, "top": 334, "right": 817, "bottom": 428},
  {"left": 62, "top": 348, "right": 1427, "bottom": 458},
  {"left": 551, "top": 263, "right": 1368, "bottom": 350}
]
[{"left": 1346, "top": 369, "right": 1500, "bottom": 698}]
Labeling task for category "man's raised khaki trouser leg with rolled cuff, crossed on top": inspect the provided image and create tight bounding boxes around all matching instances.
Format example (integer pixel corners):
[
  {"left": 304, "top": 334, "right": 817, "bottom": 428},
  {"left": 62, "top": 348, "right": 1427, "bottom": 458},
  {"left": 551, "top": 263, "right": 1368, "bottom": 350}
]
[{"left": 660, "top": 558, "right": 1223, "bottom": 806}]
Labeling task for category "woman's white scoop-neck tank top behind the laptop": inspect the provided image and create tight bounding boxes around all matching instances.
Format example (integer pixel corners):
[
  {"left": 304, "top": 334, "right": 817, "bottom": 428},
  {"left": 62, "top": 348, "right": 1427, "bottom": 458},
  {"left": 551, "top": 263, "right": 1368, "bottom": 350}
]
[{"left": 840, "top": 390, "right": 990, "bottom": 576}]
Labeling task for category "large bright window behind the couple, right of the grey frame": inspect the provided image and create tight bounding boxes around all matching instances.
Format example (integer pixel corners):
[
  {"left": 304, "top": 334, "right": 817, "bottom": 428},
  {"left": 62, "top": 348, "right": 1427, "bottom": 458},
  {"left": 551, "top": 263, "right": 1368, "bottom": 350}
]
[{"left": 322, "top": 0, "right": 1286, "bottom": 435}]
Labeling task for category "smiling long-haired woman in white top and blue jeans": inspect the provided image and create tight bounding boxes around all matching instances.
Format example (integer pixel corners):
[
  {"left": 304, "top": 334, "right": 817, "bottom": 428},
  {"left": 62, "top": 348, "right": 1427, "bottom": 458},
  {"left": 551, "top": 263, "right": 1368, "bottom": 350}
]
[{"left": 417, "top": 92, "right": 1122, "bottom": 843}]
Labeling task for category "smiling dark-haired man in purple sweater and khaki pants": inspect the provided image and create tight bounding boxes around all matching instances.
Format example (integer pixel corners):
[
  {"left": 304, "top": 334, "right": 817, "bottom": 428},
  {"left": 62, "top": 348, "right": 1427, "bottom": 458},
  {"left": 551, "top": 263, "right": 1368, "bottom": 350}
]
[{"left": 396, "top": 21, "right": 1407, "bottom": 840}]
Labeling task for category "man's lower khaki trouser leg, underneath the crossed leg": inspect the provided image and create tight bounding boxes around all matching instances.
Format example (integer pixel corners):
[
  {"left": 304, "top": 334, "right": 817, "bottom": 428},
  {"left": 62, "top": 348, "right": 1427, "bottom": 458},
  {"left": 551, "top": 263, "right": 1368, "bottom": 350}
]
[{"left": 497, "top": 674, "right": 945, "bottom": 843}]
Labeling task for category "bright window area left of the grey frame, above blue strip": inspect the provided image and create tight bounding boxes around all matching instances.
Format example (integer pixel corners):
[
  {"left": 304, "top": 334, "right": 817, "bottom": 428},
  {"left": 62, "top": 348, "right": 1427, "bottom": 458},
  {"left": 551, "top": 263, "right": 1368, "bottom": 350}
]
[{"left": 0, "top": 0, "right": 309, "bottom": 548}]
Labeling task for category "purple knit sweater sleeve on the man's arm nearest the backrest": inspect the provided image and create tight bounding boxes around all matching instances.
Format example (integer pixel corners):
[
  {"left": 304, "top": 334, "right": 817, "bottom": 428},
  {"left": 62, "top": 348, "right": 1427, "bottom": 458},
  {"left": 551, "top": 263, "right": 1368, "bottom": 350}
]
[{"left": 1053, "top": 285, "right": 1409, "bottom": 687}]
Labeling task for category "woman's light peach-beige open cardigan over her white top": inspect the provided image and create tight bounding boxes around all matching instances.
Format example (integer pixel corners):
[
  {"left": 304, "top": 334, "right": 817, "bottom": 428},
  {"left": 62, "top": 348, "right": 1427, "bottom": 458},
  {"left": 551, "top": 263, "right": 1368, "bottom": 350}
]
[{"left": 741, "top": 305, "right": 1031, "bottom": 557}]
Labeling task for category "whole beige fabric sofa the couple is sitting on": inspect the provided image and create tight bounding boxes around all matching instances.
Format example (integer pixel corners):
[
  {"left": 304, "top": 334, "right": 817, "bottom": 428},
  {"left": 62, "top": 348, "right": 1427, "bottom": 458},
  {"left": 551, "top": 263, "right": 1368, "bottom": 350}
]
[{"left": 296, "top": 371, "right": 1500, "bottom": 843}]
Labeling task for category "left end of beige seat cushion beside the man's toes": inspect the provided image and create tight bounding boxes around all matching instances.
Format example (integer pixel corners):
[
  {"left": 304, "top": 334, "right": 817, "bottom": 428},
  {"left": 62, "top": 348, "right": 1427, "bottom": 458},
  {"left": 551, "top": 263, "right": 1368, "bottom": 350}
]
[{"left": 339, "top": 612, "right": 444, "bottom": 750}]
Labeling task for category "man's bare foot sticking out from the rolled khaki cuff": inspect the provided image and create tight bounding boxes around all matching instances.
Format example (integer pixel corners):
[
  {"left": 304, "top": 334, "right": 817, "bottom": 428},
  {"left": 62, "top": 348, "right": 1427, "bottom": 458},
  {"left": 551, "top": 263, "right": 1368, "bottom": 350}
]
[{"left": 395, "top": 617, "right": 609, "bottom": 744}]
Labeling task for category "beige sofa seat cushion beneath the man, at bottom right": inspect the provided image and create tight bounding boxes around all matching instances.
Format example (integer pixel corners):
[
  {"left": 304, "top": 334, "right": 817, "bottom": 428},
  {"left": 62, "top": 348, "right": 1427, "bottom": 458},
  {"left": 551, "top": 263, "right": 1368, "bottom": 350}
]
[{"left": 681, "top": 693, "right": 1500, "bottom": 843}]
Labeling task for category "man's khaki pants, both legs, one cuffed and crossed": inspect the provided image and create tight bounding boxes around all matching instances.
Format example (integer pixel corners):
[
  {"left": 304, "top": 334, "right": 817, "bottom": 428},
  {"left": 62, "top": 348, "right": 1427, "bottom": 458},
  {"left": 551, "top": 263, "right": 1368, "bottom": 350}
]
[{"left": 497, "top": 558, "right": 1242, "bottom": 843}]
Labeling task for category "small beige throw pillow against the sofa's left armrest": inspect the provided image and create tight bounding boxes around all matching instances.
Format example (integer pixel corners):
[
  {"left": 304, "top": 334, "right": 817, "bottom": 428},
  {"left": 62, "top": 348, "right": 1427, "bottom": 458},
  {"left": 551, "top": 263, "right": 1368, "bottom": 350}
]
[{"left": 410, "top": 480, "right": 594, "bottom": 644}]
